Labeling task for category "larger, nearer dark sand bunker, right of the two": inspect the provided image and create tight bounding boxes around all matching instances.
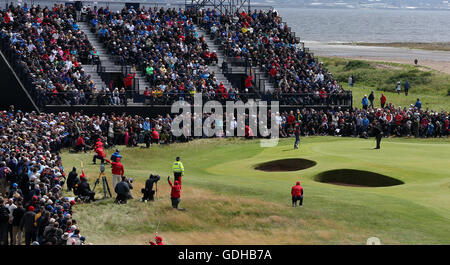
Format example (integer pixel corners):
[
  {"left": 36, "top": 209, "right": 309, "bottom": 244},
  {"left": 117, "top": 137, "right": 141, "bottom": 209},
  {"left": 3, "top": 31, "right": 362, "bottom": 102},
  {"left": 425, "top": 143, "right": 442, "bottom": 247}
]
[{"left": 314, "top": 169, "right": 404, "bottom": 187}]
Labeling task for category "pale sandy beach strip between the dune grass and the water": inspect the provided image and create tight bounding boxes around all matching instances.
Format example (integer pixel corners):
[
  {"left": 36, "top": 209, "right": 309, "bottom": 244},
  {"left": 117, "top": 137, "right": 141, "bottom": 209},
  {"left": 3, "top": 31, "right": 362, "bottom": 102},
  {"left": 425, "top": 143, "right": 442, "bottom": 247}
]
[{"left": 305, "top": 41, "right": 450, "bottom": 74}]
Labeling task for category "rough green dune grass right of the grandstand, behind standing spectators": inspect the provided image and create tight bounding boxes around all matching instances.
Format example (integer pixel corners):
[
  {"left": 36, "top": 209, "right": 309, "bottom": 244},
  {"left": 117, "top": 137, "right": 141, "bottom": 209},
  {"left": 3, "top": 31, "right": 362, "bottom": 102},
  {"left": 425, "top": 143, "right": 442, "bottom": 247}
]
[{"left": 319, "top": 57, "right": 450, "bottom": 111}]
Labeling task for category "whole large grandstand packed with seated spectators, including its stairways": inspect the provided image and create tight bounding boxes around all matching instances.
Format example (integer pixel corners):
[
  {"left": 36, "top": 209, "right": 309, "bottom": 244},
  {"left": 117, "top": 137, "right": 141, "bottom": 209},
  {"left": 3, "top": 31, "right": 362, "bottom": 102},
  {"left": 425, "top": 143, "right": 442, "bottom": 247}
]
[{"left": 0, "top": 1, "right": 352, "bottom": 114}]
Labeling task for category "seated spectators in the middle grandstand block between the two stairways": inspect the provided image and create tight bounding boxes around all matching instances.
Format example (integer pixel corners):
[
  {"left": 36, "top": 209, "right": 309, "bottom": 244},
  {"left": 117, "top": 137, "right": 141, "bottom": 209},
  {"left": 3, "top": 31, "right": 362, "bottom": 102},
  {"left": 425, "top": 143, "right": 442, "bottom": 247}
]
[{"left": 86, "top": 7, "right": 248, "bottom": 105}]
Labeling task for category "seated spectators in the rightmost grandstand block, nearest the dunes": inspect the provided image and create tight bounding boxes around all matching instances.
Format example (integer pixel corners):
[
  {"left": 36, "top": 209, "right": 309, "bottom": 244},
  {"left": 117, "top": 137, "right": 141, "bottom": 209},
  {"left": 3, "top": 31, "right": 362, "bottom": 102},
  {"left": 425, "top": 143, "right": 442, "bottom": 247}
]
[{"left": 200, "top": 9, "right": 351, "bottom": 105}]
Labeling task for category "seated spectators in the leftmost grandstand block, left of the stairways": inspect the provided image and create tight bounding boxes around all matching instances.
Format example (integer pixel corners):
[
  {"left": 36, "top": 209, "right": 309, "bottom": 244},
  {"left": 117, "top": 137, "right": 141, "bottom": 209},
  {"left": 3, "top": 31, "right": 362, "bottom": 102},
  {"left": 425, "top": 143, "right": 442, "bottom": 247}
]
[{"left": 0, "top": 3, "right": 102, "bottom": 107}]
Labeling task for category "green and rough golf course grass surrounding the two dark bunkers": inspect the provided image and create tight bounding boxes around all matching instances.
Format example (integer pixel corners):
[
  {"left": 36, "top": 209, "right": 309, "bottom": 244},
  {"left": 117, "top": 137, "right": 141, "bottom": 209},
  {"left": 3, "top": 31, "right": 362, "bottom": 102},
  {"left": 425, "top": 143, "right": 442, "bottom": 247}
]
[{"left": 62, "top": 137, "right": 450, "bottom": 244}]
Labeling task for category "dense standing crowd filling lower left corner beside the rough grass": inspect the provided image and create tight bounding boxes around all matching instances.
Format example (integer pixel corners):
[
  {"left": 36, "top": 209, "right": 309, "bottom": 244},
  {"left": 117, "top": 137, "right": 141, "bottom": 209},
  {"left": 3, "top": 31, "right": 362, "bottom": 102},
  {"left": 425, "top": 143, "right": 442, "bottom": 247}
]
[{"left": 0, "top": 104, "right": 89, "bottom": 245}]
